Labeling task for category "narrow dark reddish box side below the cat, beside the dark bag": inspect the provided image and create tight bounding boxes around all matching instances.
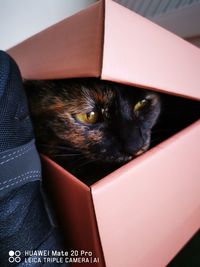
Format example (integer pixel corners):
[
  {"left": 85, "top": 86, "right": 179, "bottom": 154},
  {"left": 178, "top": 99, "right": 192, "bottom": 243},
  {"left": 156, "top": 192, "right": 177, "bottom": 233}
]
[{"left": 42, "top": 156, "right": 104, "bottom": 267}]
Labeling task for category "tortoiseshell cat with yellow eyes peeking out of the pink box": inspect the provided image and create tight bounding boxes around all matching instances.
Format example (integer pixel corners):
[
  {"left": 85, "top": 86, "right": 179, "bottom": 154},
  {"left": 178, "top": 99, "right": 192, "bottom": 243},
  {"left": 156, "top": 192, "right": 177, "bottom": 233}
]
[{"left": 24, "top": 78, "right": 161, "bottom": 184}]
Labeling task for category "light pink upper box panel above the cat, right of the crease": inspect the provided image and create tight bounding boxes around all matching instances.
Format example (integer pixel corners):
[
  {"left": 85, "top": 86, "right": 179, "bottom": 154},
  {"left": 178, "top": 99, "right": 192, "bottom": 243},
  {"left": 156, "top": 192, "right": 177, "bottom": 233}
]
[{"left": 102, "top": 0, "right": 200, "bottom": 99}]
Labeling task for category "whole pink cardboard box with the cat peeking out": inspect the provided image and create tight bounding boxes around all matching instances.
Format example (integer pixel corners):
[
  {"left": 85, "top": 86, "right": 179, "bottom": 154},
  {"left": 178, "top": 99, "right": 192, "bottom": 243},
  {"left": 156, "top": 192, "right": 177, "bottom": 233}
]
[{"left": 8, "top": 0, "right": 200, "bottom": 267}]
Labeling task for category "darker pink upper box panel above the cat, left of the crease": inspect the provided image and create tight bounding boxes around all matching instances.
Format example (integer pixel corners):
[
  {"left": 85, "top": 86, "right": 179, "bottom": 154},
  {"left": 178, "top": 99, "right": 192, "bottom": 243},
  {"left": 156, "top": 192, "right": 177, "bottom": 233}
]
[{"left": 7, "top": 2, "right": 103, "bottom": 79}]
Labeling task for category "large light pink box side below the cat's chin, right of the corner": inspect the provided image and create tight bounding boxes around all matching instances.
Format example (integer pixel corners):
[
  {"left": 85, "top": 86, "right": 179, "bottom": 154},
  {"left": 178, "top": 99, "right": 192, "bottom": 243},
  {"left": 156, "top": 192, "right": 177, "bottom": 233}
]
[{"left": 92, "top": 121, "right": 200, "bottom": 267}]
